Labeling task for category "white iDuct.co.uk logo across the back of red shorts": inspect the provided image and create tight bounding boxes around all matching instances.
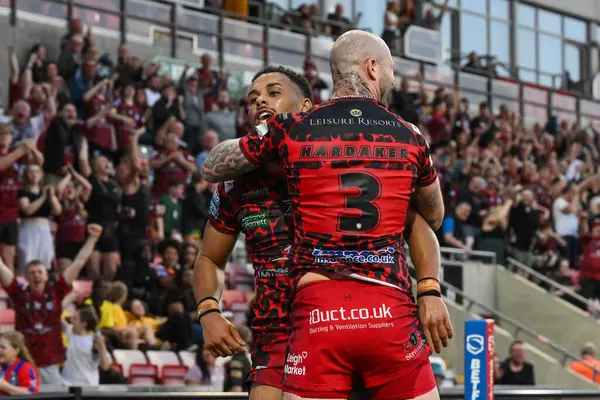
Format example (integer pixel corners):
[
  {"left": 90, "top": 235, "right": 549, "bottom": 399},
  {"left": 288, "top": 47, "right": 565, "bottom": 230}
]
[{"left": 308, "top": 304, "right": 394, "bottom": 333}]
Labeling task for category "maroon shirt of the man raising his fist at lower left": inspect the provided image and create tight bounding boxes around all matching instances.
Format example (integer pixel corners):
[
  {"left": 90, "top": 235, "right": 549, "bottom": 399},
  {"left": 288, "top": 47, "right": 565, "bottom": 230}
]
[{"left": 6, "top": 275, "right": 71, "bottom": 368}]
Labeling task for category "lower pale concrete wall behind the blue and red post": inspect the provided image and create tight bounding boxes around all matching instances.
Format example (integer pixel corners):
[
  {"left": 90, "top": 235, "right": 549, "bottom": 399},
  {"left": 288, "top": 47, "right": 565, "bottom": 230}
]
[{"left": 441, "top": 300, "right": 598, "bottom": 389}]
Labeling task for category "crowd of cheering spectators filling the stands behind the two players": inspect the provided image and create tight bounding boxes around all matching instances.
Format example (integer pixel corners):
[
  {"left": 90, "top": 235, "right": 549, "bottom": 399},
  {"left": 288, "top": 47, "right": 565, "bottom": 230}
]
[{"left": 0, "top": 0, "right": 600, "bottom": 392}]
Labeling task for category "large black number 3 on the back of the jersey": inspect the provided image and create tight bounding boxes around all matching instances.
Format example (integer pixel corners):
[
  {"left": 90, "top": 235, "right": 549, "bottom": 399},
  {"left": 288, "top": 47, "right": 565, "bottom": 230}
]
[{"left": 337, "top": 172, "right": 381, "bottom": 234}]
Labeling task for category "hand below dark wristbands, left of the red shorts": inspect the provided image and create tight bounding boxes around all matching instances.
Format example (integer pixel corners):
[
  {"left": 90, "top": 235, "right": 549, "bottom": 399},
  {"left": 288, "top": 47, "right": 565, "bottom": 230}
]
[{"left": 200, "top": 313, "right": 246, "bottom": 357}]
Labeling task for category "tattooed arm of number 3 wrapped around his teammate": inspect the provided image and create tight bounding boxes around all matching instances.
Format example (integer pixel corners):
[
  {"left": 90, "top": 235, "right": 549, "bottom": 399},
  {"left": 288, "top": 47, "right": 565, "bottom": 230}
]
[{"left": 202, "top": 139, "right": 258, "bottom": 183}]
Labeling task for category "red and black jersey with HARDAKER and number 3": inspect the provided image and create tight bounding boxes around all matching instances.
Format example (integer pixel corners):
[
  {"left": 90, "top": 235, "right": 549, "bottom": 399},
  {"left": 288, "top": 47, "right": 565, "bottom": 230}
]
[{"left": 240, "top": 97, "right": 437, "bottom": 291}]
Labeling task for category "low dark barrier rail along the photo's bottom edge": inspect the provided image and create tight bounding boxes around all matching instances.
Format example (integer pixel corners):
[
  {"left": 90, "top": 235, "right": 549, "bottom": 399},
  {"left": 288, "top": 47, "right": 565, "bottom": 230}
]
[{"left": 29, "top": 386, "right": 600, "bottom": 400}]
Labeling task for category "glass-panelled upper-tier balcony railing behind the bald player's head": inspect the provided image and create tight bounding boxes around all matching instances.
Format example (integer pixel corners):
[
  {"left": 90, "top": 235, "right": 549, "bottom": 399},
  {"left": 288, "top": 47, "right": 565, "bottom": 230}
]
[{"left": 7, "top": 0, "right": 600, "bottom": 124}]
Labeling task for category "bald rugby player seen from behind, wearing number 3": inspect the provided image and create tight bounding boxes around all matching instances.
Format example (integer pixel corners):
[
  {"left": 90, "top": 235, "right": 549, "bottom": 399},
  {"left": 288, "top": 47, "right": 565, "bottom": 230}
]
[{"left": 203, "top": 31, "right": 452, "bottom": 399}]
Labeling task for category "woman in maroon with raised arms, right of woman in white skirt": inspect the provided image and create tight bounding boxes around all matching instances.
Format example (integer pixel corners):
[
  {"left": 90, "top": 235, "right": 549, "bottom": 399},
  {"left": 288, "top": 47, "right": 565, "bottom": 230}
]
[{"left": 56, "top": 165, "right": 92, "bottom": 274}]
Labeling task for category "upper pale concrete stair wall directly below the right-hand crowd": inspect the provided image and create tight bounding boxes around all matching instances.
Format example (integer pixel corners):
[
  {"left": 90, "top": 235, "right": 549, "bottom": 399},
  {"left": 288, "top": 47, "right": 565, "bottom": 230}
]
[{"left": 496, "top": 268, "right": 600, "bottom": 355}]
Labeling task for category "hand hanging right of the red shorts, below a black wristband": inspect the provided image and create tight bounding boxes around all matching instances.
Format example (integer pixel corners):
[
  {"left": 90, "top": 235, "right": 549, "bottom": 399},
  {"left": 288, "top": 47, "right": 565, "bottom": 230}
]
[{"left": 418, "top": 296, "right": 454, "bottom": 353}]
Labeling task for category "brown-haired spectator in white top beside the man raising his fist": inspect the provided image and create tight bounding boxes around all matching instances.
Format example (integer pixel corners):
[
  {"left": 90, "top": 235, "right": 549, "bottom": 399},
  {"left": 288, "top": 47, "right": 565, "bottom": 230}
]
[{"left": 62, "top": 306, "right": 111, "bottom": 386}]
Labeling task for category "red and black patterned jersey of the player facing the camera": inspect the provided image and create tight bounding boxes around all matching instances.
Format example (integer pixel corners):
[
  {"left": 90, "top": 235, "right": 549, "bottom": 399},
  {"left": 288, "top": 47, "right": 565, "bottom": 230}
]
[{"left": 209, "top": 168, "right": 292, "bottom": 332}]
